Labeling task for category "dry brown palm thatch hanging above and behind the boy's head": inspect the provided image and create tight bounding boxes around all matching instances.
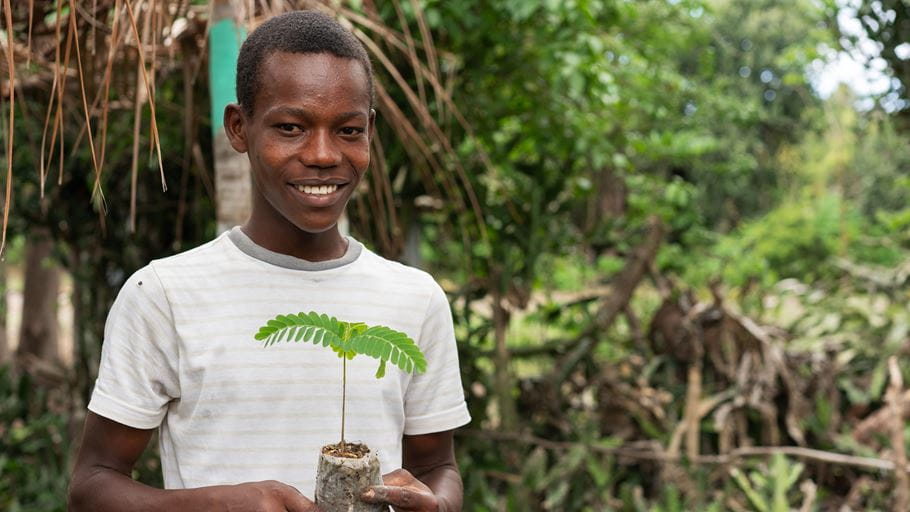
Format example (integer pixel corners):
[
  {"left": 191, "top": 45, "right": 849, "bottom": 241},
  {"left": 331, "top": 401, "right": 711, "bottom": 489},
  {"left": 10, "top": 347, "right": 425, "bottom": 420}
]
[{"left": 0, "top": 0, "right": 491, "bottom": 254}]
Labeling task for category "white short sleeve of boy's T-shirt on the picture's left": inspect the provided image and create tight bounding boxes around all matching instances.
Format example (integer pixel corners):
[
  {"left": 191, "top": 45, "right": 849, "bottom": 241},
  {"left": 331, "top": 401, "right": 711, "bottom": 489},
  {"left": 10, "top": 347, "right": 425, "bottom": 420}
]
[{"left": 88, "top": 266, "right": 180, "bottom": 429}]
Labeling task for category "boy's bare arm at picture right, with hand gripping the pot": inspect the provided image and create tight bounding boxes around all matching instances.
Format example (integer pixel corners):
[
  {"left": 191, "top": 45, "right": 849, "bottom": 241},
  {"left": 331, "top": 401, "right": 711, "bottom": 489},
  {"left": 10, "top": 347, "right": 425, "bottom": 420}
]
[{"left": 364, "top": 430, "right": 464, "bottom": 512}]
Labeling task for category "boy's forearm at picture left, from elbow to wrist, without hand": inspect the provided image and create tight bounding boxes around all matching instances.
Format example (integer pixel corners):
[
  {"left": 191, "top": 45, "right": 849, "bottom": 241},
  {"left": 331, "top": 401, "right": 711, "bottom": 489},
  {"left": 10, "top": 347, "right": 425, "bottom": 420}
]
[{"left": 69, "top": 467, "right": 227, "bottom": 512}]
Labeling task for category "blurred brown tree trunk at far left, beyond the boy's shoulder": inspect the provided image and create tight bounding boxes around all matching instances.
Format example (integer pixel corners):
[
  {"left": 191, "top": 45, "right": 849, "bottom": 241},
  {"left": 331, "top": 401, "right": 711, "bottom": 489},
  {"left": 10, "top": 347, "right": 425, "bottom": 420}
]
[{"left": 16, "top": 229, "right": 60, "bottom": 363}]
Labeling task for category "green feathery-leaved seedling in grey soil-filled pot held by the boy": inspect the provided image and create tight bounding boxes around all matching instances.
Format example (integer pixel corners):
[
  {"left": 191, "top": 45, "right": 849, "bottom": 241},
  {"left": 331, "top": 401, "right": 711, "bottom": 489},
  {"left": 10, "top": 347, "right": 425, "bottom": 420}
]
[{"left": 255, "top": 311, "right": 427, "bottom": 512}]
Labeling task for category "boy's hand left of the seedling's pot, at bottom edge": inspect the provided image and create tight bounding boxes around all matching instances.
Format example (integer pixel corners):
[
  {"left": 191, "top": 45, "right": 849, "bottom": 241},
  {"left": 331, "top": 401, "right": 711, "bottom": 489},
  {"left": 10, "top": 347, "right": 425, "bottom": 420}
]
[{"left": 219, "top": 480, "right": 319, "bottom": 512}]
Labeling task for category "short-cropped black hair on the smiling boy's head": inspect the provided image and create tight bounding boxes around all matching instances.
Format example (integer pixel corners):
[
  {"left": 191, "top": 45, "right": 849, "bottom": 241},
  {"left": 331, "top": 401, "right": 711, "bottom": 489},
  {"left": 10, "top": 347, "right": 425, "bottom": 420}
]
[{"left": 237, "top": 11, "right": 373, "bottom": 115}]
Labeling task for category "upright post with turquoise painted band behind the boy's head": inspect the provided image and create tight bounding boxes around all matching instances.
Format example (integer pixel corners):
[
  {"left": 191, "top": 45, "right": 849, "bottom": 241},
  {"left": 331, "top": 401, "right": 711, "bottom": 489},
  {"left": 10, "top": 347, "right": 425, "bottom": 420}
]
[{"left": 209, "top": 0, "right": 252, "bottom": 233}]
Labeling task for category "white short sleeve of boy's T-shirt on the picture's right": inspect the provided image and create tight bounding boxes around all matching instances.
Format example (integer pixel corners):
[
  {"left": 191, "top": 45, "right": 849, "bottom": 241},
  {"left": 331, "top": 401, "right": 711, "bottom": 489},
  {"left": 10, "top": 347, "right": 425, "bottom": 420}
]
[{"left": 404, "top": 282, "right": 471, "bottom": 435}]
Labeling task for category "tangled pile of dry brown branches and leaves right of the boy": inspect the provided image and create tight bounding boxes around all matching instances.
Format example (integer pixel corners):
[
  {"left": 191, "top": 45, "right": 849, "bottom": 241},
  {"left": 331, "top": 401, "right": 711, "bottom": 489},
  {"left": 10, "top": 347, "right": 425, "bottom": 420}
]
[{"left": 465, "top": 258, "right": 910, "bottom": 510}]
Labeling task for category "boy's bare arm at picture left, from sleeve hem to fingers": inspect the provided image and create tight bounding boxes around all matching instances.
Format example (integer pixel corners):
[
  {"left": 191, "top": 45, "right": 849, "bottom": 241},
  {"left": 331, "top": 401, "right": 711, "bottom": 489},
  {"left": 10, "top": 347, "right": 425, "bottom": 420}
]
[{"left": 69, "top": 412, "right": 318, "bottom": 512}]
